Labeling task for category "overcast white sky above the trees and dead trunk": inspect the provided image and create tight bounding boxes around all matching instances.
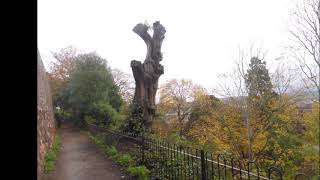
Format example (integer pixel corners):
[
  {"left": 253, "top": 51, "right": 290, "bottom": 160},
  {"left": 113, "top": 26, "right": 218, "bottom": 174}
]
[{"left": 38, "top": 0, "right": 293, "bottom": 89}]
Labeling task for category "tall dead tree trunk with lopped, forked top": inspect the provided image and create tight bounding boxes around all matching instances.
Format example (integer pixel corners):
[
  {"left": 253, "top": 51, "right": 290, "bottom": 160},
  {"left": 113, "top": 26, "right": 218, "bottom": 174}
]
[{"left": 131, "top": 21, "right": 166, "bottom": 129}]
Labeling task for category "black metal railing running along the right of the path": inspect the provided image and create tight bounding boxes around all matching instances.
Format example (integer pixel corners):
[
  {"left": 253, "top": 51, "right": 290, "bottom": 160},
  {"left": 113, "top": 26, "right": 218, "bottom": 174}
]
[{"left": 89, "top": 125, "right": 310, "bottom": 180}]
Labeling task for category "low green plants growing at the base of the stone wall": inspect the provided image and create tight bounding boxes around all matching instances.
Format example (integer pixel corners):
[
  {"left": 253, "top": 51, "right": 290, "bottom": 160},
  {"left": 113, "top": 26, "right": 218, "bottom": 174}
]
[{"left": 44, "top": 134, "right": 61, "bottom": 174}]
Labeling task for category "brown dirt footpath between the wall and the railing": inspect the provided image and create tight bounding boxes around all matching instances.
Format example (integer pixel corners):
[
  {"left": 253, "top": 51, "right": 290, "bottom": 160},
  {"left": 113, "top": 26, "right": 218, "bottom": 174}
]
[{"left": 44, "top": 127, "right": 129, "bottom": 180}]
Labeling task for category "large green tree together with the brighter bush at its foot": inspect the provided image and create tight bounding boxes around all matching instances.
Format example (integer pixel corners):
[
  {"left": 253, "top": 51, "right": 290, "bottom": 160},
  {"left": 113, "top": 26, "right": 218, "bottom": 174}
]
[{"left": 61, "top": 53, "right": 122, "bottom": 126}]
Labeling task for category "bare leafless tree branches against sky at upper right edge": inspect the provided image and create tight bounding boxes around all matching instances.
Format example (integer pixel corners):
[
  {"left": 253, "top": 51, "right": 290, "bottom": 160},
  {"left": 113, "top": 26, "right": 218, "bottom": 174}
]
[{"left": 289, "top": 0, "right": 320, "bottom": 98}]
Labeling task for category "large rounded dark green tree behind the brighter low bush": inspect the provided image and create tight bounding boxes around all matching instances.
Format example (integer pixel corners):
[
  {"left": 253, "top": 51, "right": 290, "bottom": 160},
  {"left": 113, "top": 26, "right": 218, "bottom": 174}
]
[{"left": 67, "top": 53, "right": 122, "bottom": 126}]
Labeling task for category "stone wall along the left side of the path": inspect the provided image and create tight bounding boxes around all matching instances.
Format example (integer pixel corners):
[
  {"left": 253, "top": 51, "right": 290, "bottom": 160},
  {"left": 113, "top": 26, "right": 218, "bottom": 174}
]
[{"left": 37, "top": 51, "right": 56, "bottom": 180}]
